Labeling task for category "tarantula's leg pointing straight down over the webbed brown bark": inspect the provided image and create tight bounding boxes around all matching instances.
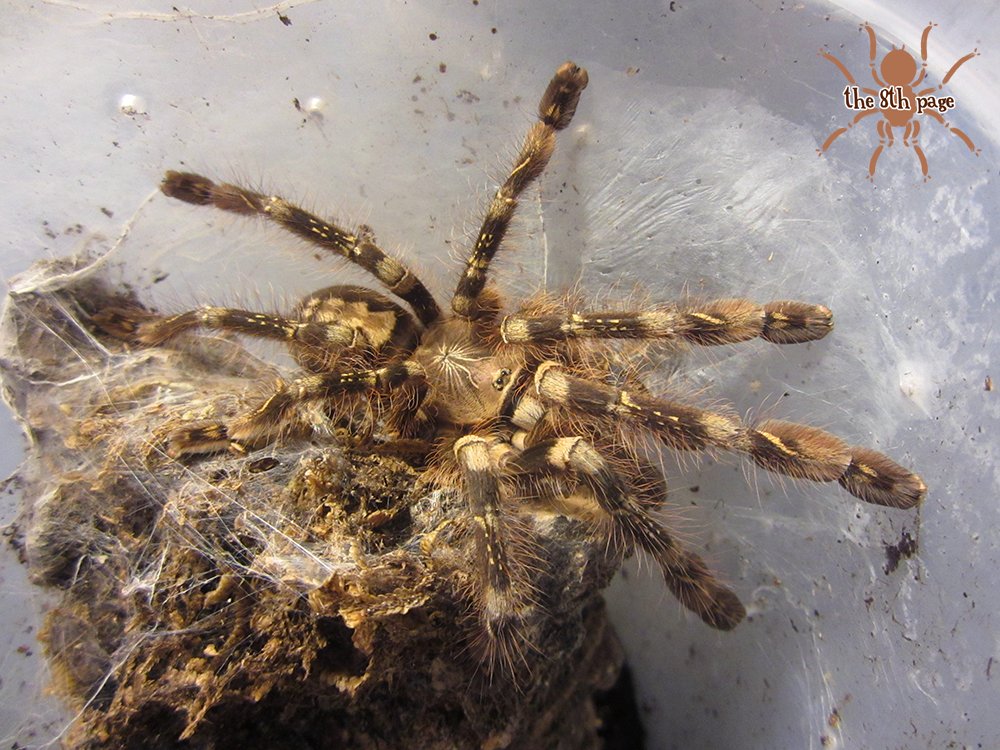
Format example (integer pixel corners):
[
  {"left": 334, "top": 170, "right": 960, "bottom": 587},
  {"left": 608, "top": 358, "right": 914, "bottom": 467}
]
[{"left": 454, "top": 435, "right": 531, "bottom": 674}]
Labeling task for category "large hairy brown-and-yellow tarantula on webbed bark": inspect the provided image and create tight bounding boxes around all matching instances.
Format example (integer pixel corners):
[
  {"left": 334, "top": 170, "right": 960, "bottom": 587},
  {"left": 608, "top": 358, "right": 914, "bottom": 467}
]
[{"left": 96, "top": 62, "right": 926, "bottom": 664}]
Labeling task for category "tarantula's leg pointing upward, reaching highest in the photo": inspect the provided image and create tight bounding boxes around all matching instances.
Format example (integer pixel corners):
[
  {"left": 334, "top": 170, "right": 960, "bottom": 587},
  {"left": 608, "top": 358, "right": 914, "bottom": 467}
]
[{"left": 451, "top": 62, "right": 587, "bottom": 318}]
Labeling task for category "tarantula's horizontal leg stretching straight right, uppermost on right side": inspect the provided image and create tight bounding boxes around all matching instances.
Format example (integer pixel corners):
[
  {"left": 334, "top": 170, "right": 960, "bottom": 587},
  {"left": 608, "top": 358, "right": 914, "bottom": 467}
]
[{"left": 500, "top": 299, "right": 833, "bottom": 346}]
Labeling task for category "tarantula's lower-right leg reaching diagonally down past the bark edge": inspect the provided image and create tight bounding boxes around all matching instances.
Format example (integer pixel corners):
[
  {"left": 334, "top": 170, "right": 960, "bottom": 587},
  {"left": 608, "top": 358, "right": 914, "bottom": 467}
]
[{"left": 504, "top": 437, "right": 746, "bottom": 630}]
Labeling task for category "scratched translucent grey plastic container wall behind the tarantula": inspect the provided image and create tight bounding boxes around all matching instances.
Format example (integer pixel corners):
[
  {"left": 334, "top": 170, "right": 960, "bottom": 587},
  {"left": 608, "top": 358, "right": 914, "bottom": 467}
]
[{"left": 0, "top": 0, "right": 1000, "bottom": 748}]
